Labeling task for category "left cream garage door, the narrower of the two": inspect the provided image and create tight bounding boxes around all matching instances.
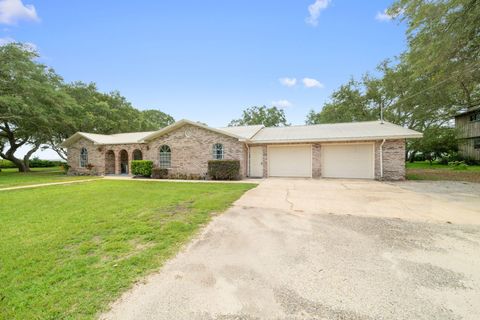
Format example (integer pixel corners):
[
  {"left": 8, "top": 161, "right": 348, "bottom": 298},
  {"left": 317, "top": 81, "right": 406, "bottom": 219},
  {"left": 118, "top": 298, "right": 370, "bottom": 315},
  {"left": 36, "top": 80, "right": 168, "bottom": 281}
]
[{"left": 267, "top": 145, "right": 312, "bottom": 177}]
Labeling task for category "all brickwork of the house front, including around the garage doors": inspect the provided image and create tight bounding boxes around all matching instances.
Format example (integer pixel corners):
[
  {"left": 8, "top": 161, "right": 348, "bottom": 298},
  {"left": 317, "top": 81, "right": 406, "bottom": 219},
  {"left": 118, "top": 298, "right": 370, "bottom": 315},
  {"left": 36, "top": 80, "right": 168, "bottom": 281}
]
[{"left": 68, "top": 124, "right": 405, "bottom": 180}]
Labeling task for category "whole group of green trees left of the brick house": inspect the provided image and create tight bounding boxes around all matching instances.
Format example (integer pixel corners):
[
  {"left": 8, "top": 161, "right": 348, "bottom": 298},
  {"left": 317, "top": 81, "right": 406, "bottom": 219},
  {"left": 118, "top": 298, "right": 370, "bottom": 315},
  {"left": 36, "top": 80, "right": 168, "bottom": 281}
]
[{"left": 0, "top": 43, "right": 174, "bottom": 172}]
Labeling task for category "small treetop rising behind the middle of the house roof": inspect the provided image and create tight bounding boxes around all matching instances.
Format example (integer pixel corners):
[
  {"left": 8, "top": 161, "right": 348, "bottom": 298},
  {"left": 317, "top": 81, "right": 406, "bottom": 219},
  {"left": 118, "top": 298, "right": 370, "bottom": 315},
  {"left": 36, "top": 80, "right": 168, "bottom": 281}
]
[{"left": 228, "top": 106, "right": 289, "bottom": 127}]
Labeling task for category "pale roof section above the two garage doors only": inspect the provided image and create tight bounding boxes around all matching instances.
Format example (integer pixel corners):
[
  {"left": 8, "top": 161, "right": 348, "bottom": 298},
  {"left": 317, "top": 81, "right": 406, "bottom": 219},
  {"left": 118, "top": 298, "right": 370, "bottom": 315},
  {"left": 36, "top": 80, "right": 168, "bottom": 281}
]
[{"left": 251, "top": 121, "right": 422, "bottom": 143}]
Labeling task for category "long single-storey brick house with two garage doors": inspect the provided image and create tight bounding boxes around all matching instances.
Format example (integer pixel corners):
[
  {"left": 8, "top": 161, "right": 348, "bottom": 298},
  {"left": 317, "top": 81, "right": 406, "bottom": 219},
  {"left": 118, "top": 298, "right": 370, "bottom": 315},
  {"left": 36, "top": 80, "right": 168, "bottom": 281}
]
[{"left": 62, "top": 120, "right": 422, "bottom": 180}]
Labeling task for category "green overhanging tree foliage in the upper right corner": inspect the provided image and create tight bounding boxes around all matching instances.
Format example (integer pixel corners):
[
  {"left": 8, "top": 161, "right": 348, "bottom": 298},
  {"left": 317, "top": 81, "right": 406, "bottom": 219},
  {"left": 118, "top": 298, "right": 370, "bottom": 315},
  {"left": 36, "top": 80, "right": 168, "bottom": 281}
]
[{"left": 388, "top": 0, "right": 480, "bottom": 108}]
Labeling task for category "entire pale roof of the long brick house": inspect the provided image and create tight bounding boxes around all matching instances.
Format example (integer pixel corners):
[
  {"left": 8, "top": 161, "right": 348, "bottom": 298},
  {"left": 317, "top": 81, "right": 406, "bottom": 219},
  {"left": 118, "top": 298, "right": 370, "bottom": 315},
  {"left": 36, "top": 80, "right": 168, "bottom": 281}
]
[{"left": 62, "top": 120, "right": 422, "bottom": 147}]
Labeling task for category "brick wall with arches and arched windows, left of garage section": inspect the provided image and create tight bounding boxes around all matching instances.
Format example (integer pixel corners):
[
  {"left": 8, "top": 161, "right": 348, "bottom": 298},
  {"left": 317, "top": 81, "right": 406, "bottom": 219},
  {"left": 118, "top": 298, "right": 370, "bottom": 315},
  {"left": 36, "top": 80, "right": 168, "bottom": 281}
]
[{"left": 68, "top": 125, "right": 247, "bottom": 177}]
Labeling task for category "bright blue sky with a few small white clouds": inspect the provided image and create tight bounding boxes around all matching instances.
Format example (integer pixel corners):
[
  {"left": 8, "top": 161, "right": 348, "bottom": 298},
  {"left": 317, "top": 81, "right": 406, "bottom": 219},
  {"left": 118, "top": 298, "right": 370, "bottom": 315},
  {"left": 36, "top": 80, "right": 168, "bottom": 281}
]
[{"left": 0, "top": 0, "right": 406, "bottom": 158}]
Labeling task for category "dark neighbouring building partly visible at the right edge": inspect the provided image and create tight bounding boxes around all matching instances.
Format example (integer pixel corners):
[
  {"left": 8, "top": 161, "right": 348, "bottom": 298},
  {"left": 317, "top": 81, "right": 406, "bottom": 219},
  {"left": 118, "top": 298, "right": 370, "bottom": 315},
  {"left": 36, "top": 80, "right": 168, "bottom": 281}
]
[{"left": 455, "top": 105, "right": 480, "bottom": 161}]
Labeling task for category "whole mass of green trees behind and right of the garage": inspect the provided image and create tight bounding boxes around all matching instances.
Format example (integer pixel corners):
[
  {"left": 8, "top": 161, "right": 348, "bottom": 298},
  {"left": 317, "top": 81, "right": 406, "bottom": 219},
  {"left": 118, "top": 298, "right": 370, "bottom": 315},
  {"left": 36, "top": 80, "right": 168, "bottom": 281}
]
[{"left": 306, "top": 0, "right": 480, "bottom": 157}]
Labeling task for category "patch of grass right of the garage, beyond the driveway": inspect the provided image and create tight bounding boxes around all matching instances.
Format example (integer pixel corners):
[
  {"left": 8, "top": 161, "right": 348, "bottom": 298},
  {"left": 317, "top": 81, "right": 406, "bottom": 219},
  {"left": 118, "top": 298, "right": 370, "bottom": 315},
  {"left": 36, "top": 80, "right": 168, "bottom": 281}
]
[{"left": 406, "top": 161, "right": 480, "bottom": 182}]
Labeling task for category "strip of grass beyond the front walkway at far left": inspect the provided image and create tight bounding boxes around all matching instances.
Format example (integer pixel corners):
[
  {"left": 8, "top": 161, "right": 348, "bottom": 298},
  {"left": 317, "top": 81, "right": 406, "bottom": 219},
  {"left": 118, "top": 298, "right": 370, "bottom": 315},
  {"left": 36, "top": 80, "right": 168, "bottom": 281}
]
[{"left": 0, "top": 167, "right": 95, "bottom": 188}]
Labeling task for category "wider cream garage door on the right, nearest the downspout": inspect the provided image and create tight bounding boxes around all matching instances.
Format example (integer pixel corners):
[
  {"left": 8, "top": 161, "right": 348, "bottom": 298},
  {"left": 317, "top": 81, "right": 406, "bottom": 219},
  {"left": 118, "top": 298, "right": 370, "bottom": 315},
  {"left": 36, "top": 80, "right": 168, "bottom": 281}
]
[{"left": 321, "top": 144, "right": 374, "bottom": 179}]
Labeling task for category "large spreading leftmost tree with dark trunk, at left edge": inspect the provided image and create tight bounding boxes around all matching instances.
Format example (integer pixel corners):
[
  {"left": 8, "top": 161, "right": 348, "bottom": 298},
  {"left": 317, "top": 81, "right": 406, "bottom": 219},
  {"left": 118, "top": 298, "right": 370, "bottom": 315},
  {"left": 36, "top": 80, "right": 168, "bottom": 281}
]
[{"left": 0, "top": 43, "right": 72, "bottom": 172}]
